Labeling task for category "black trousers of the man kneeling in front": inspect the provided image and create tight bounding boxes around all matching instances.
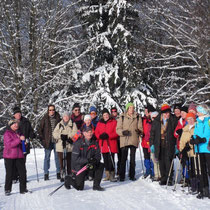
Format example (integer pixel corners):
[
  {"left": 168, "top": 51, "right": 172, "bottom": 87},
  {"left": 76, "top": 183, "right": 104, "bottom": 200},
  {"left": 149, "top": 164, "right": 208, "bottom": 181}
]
[{"left": 71, "top": 163, "right": 104, "bottom": 190}]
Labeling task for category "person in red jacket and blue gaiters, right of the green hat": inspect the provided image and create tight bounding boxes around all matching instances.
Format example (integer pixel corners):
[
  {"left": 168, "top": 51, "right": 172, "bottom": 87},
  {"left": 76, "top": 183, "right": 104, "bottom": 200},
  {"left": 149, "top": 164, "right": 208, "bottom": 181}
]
[{"left": 141, "top": 105, "right": 155, "bottom": 178}]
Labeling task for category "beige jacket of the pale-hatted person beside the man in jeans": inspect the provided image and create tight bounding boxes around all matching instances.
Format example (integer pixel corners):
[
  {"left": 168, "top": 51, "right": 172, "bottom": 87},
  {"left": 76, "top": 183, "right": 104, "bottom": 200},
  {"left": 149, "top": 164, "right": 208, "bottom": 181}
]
[{"left": 53, "top": 120, "right": 77, "bottom": 152}]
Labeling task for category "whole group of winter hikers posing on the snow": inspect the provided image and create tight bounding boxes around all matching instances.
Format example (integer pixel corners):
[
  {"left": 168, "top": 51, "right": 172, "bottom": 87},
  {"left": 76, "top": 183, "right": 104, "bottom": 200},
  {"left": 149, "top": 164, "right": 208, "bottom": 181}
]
[{"left": 3, "top": 102, "right": 210, "bottom": 198}]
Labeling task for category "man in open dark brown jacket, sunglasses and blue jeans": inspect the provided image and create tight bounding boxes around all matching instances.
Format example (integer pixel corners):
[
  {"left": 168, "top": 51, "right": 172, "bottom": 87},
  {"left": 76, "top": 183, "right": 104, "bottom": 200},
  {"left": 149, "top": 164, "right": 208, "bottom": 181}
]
[{"left": 39, "top": 105, "right": 61, "bottom": 181}]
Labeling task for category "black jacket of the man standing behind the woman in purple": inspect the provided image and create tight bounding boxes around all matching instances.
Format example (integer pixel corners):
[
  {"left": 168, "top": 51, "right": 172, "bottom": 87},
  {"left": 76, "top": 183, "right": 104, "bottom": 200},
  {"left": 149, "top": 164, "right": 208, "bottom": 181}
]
[{"left": 18, "top": 117, "right": 35, "bottom": 154}]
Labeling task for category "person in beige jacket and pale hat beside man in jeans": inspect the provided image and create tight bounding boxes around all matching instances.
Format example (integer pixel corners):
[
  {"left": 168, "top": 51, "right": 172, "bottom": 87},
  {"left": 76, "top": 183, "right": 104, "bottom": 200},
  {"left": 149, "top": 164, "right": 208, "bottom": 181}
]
[{"left": 53, "top": 111, "right": 77, "bottom": 182}]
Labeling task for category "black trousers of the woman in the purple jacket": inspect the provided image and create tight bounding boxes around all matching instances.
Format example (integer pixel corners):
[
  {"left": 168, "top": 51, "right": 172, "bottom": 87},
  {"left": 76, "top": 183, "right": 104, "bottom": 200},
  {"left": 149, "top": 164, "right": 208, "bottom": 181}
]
[{"left": 4, "top": 158, "right": 26, "bottom": 192}]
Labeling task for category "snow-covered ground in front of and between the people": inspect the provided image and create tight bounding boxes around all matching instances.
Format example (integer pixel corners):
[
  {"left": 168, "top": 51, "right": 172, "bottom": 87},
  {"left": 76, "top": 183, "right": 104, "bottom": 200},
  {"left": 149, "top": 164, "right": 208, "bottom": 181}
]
[{"left": 0, "top": 149, "right": 210, "bottom": 210}]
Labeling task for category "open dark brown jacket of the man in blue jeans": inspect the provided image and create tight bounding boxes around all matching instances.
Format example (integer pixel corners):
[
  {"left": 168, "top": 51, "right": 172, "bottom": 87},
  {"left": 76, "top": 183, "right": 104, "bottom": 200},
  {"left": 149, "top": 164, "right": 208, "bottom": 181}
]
[{"left": 39, "top": 112, "right": 61, "bottom": 149}]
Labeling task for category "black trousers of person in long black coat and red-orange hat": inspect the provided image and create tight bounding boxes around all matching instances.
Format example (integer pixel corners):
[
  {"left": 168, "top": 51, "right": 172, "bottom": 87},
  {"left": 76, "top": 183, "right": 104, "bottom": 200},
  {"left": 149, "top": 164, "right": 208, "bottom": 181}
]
[{"left": 159, "top": 147, "right": 173, "bottom": 182}]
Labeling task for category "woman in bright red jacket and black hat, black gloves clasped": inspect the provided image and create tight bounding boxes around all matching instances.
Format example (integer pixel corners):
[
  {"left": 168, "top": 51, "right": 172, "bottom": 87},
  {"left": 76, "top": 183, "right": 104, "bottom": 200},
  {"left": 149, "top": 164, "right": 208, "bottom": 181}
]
[{"left": 95, "top": 108, "right": 118, "bottom": 182}]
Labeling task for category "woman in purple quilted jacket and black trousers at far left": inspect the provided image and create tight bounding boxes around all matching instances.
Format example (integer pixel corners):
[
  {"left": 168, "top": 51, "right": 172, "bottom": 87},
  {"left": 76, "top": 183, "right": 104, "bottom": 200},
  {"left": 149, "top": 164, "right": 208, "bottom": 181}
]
[{"left": 3, "top": 119, "right": 28, "bottom": 196}]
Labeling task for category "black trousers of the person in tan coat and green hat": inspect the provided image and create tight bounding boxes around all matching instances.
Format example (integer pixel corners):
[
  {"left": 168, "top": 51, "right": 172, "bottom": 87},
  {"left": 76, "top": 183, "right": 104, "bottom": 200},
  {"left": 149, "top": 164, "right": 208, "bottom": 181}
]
[{"left": 120, "top": 146, "right": 136, "bottom": 179}]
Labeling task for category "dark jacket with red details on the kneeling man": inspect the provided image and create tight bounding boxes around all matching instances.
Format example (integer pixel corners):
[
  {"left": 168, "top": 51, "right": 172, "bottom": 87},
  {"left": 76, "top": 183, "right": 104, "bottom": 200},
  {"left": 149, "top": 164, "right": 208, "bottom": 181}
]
[{"left": 71, "top": 137, "right": 101, "bottom": 172}]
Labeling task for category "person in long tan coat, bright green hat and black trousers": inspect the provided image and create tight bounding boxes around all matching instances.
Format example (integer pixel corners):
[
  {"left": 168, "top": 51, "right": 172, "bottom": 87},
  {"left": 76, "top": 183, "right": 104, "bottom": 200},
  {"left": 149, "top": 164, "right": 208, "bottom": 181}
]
[{"left": 116, "top": 102, "right": 143, "bottom": 182}]
